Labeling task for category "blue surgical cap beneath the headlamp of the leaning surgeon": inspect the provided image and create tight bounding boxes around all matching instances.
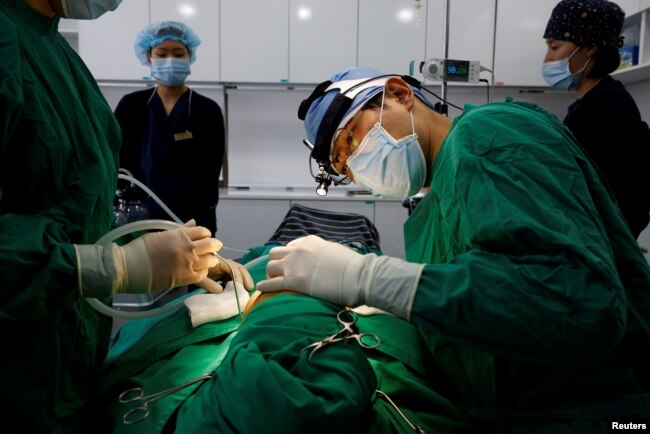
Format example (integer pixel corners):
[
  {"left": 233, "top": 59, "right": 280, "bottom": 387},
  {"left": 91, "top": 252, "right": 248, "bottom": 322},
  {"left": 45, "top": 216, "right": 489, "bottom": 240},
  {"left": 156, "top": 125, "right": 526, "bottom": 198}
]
[{"left": 305, "top": 66, "right": 433, "bottom": 156}]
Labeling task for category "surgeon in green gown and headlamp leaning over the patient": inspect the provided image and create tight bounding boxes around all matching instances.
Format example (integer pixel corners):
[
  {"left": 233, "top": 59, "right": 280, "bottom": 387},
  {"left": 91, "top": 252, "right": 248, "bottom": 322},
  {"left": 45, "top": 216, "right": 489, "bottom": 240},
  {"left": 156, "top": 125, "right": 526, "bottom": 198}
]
[{"left": 257, "top": 67, "right": 650, "bottom": 433}]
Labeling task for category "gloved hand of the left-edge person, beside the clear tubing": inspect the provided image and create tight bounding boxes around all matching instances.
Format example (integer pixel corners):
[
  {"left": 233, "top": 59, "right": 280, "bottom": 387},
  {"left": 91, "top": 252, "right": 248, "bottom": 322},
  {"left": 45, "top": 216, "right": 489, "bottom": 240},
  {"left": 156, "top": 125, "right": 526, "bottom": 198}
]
[{"left": 74, "top": 226, "right": 222, "bottom": 297}]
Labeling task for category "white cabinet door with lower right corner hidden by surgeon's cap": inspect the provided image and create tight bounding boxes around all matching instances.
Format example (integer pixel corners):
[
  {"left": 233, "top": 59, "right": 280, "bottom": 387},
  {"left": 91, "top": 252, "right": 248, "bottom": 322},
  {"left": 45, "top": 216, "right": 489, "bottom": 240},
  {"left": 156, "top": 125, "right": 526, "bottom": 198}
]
[{"left": 289, "top": 0, "right": 356, "bottom": 83}]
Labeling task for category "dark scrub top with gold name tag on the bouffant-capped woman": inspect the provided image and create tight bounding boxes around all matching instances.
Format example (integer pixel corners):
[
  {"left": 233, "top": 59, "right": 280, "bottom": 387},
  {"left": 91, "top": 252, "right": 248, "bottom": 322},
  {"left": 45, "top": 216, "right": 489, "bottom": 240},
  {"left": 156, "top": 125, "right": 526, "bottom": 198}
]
[{"left": 115, "top": 89, "right": 225, "bottom": 232}]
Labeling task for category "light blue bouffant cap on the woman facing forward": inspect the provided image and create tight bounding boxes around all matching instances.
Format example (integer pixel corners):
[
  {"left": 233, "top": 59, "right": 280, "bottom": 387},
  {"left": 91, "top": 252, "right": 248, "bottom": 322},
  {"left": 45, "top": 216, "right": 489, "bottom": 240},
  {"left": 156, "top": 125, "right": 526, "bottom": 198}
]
[{"left": 133, "top": 21, "right": 201, "bottom": 65}]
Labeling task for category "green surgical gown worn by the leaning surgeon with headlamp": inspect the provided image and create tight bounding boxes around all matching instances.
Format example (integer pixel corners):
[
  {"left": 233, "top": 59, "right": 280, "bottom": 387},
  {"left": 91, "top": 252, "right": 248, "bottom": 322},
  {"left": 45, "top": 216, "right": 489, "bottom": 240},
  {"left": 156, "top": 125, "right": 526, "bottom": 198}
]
[{"left": 404, "top": 101, "right": 650, "bottom": 432}]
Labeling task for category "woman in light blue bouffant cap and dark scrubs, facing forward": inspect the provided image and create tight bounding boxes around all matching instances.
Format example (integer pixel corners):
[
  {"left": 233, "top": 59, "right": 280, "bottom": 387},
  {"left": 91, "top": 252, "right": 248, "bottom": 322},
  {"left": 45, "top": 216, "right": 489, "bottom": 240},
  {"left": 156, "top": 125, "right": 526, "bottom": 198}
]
[{"left": 115, "top": 21, "right": 225, "bottom": 232}]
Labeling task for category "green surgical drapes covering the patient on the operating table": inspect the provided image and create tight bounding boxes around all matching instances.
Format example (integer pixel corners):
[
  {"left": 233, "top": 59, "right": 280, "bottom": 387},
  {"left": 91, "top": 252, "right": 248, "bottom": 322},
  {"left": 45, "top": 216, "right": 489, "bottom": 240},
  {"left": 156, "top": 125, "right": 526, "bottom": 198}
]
[{"left": 97, "top": 245, "right": 468, "bottom": 434}]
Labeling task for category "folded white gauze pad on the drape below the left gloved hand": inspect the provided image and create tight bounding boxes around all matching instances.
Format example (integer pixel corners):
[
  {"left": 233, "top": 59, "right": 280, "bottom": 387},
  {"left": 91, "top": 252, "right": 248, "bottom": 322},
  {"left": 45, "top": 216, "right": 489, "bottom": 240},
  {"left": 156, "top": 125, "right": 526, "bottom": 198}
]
[{"left": 183, "top": 281, "right": 250, "bottom": 327}]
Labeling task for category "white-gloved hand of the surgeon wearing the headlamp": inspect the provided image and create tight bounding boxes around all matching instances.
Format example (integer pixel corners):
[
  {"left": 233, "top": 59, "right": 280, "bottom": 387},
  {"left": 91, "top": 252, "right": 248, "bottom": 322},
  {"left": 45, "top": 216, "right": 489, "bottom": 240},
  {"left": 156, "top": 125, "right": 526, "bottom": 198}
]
[{"left": 256, "top": 235, "right": 424, "bottom": 319}]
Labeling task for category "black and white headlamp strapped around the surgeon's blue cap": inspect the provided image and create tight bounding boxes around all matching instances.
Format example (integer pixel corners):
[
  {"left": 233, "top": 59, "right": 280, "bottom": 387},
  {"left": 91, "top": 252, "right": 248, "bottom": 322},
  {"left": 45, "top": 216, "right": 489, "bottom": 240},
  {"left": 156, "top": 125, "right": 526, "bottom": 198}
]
[{"left": 298, "top": 74, "right": 421, "bottom": 196}]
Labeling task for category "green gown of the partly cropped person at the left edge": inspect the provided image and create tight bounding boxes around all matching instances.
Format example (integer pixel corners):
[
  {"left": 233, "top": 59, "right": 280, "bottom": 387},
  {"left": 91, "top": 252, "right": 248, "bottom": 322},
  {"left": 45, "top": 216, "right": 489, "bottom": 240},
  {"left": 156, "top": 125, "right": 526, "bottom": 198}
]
[{"left": 0, "top": 0, "right": 120, "bottom": 433}]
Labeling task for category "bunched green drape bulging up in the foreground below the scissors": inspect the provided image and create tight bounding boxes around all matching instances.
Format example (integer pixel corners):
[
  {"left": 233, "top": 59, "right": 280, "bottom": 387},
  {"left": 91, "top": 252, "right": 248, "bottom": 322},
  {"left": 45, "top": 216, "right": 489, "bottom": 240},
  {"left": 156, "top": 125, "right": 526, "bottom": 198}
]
[{"left": 175, "top": 295, "right": 376, "bottom": 434}]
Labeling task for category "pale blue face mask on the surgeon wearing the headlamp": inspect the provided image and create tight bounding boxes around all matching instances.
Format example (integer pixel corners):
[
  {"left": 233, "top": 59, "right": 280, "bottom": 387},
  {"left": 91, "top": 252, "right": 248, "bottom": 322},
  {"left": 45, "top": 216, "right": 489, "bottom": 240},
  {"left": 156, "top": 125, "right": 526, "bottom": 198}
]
[{"left": 346, "top": 94, "right": 427, "bottom": 199}]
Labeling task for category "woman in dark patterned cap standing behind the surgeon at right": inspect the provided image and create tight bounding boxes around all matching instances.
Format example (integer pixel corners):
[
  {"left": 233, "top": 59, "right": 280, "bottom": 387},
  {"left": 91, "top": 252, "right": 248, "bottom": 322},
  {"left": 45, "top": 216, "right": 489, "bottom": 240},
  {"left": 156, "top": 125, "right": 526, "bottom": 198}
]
[{"left": 542, "top": 0, "right": 650, "bottom": 238}]
